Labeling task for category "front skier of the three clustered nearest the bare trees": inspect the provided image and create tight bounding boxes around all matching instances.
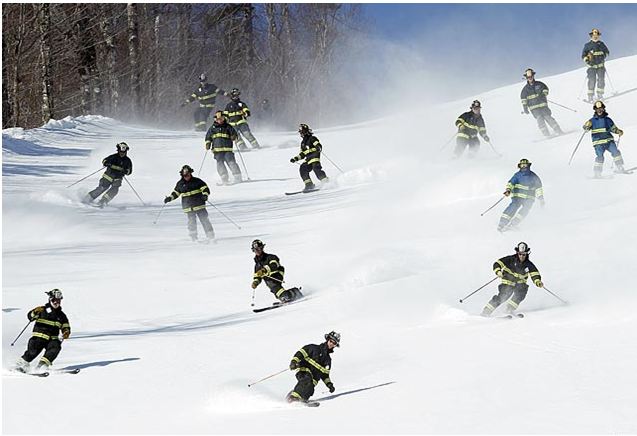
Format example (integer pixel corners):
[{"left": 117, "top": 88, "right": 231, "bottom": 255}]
[{"left": 206, "top": 111, "right": 242, "bottom": 185}]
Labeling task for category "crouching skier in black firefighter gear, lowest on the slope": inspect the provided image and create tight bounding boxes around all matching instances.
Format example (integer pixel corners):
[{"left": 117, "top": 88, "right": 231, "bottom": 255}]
[{"left": 286, "top": 331, "right": 341, "bottom": 403}]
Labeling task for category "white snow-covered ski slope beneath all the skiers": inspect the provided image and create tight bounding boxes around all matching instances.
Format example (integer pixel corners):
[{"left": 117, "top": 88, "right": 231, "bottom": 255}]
[{"left": 2, "top": 57, "right": 637, "bottom": 434}]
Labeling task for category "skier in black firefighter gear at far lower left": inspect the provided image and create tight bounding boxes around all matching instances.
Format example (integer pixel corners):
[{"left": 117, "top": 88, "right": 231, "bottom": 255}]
[{"left": 15, "top": 289, "right": 71, "bottom": 373}]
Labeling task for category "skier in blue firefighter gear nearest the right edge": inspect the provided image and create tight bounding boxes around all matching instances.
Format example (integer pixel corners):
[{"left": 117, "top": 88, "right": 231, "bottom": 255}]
[{"left": 583, "top": 101, "right": 630, "bottom": 179}]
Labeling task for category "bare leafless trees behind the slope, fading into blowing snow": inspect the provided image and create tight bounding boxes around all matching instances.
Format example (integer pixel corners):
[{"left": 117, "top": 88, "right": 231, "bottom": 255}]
[{"left": 2, "top": 3, "right": 364, "bottom": 128}]
